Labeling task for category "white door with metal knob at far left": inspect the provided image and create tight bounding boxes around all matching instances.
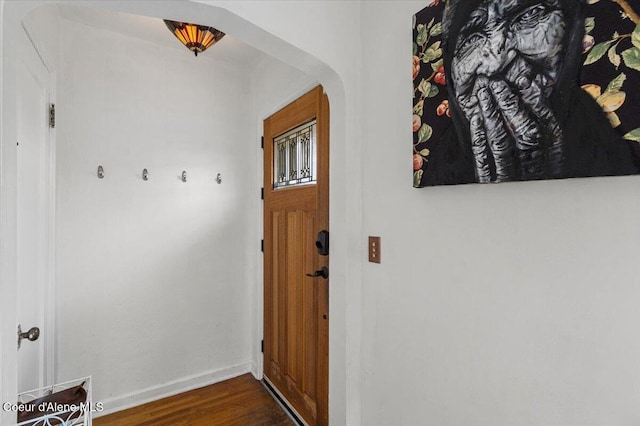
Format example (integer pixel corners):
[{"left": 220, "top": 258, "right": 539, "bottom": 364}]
[{"left": 16, "top": 25, "right": 52, "bottom": 392}]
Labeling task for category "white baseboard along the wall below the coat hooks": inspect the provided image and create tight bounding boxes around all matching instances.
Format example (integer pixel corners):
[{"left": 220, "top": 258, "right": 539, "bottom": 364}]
[{"left": 93, "top": 362, "right": 252, "bottom": 418}]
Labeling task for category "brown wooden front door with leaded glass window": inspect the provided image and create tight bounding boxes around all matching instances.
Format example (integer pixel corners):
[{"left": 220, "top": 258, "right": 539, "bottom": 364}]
[{"left": 264, "top": 86, "right": 329, "bottom": 425}]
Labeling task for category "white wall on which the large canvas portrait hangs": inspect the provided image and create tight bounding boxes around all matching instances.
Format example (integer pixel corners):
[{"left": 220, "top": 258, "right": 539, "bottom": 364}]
[{"left": 361, "top": 1, "right": 640, "bottom": 426}]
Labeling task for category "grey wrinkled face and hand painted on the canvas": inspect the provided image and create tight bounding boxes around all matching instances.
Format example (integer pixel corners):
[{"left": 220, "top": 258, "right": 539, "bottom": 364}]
[{"left": 451, "top": 0, "right": 565, "bottom": 182}]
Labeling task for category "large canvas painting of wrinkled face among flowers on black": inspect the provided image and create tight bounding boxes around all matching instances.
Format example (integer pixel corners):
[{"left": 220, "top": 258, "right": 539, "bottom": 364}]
[{"left": 412, "top": 0, "right": 640, "bottom": 187}]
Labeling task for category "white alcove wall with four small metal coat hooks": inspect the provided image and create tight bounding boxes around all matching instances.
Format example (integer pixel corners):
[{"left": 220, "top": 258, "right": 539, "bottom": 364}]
[{"left": 56, "top": 15, "right": 258, "bottom": 408}]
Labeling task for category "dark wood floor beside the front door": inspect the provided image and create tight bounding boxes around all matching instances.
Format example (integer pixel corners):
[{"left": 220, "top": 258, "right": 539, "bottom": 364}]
[{"left": 93, "top": 374, "right": 294, "bottom": 426}]
